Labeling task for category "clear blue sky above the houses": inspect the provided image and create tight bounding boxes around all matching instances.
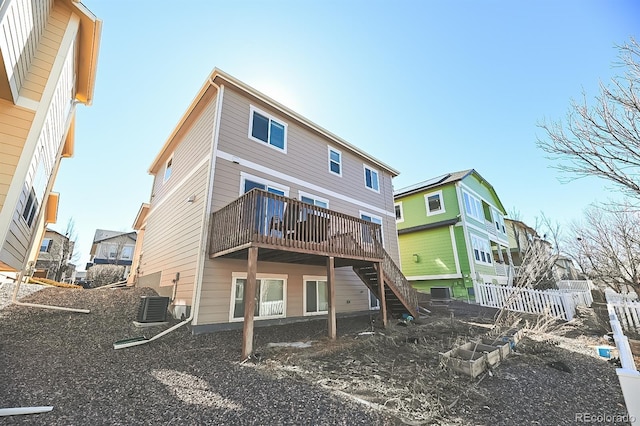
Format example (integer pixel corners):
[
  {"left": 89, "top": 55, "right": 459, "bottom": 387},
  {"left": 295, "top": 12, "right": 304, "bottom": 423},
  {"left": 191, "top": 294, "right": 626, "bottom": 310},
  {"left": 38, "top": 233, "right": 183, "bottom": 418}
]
[{"left": 53, "top": 0, "right": 640, "bottom": 269}]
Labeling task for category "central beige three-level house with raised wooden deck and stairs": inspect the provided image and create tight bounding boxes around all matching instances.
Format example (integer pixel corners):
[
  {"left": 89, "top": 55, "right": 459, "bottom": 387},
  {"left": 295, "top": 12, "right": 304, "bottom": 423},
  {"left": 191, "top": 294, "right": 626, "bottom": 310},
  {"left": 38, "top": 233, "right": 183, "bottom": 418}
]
[{"left": 134, "top": 69, "right": 417, "bottom": 355}]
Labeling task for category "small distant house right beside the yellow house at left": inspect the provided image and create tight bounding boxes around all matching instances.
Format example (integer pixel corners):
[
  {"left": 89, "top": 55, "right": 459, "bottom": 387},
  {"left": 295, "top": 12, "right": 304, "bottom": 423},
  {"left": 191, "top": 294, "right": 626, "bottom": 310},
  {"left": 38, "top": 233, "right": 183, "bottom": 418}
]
[{"left": 33, "top": 228, "right": 75, "bottom": 281}]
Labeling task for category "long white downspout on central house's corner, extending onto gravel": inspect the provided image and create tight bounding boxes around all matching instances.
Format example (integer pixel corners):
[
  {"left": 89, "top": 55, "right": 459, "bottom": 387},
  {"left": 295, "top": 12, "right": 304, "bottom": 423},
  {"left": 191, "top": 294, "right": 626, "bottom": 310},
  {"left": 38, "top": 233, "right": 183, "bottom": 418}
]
[{"left": 113, "top": 77, "right": 224, "bottom": 349}]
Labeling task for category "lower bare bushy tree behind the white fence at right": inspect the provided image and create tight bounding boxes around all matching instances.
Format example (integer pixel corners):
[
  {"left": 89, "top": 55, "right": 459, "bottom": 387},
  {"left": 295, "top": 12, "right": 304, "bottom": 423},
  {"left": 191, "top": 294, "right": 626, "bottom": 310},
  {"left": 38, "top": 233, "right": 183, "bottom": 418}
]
[{"left": 567, "top": 206, "right": 640, "bottom": 294}]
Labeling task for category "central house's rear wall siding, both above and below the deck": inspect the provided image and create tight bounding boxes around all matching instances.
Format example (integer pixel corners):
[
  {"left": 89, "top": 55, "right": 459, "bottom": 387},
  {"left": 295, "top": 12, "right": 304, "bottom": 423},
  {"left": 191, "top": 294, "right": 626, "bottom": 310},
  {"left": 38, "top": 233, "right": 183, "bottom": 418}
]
[{"left": 194, "top": 87, "right": 399, "bottom": 325}]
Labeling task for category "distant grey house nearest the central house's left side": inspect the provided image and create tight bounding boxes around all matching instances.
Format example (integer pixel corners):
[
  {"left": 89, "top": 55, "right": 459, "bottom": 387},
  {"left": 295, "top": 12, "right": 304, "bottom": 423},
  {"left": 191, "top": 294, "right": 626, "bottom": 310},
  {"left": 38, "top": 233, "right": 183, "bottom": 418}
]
[{"left": 87, "top": 229, "right": 137, "bottom": 277}]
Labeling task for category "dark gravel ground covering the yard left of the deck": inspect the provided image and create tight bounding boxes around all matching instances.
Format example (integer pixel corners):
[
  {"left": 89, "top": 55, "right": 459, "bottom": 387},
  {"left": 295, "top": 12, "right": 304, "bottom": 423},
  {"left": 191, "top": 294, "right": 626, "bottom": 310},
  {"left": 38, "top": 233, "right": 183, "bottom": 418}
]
[{"left": 0, "top": 288, "right": 397, "bottom": 425}]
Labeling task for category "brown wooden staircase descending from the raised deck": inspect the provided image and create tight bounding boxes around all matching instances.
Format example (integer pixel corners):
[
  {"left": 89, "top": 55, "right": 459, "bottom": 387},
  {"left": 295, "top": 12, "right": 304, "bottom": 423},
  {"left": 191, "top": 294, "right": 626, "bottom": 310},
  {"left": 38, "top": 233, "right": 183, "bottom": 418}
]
[{"left": 353, "top": 251, "right": 418, "bottom": 318}]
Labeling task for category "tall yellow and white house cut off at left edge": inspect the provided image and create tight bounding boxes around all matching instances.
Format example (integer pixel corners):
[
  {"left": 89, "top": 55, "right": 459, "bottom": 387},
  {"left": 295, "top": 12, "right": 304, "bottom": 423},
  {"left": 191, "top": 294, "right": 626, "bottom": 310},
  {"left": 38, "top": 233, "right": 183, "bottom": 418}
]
[{"left": 0, "top": 0, "right": 101, "bottom": 282}]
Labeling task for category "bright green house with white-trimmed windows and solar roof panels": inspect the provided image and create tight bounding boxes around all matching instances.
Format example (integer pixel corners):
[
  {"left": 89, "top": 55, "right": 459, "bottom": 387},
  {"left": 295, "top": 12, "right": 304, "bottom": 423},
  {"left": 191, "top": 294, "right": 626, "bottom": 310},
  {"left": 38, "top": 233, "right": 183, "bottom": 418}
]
[{"left": 394, "top": 169, "right": 513, "bottom": 301}]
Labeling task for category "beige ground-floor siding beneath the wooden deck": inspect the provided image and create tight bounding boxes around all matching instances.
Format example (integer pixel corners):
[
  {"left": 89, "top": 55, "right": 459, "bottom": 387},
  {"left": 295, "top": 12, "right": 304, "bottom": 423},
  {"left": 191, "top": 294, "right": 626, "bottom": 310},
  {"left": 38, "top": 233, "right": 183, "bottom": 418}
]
[{"left": 194, "top": 259, "right": 369, "bottom": 325}]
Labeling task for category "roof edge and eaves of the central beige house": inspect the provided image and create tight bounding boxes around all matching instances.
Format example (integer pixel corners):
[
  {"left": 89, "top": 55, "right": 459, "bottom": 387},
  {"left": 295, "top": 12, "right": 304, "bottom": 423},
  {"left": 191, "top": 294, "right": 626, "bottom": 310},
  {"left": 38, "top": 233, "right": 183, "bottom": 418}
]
[{"left": 149, "top": 68, "right": 400, "bottom": 177}]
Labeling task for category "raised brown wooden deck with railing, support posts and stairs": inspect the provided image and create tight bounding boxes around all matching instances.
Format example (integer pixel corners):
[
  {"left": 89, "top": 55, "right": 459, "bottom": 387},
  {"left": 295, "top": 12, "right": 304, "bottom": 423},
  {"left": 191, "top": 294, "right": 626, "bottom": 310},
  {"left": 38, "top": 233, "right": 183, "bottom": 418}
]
[{"left": 209, "top": 189, "right": 418, "bottom": 358}]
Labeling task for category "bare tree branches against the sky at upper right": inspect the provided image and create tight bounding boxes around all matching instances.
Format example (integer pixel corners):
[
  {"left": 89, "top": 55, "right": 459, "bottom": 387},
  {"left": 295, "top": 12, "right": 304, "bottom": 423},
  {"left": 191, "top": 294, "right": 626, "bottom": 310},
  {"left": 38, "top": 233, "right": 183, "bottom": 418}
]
[{"left": 538, "top": 38, "right": 640, "bottom": 199}]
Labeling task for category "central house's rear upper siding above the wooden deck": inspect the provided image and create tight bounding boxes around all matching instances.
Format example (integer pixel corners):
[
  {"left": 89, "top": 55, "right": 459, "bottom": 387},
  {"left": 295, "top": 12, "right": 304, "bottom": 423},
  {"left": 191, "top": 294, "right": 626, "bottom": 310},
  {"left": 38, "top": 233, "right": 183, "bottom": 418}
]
[{"left": 213, "top": 88, "right": 399, "bottom": 250}]
